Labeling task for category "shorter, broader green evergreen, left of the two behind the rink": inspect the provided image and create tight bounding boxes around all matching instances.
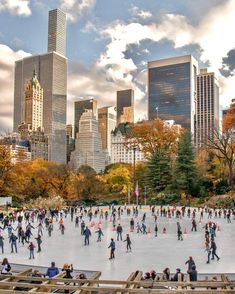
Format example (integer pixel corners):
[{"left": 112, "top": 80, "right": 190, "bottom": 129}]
[{"left": 145, "top": 150, "right": 171, "bottom": 193}]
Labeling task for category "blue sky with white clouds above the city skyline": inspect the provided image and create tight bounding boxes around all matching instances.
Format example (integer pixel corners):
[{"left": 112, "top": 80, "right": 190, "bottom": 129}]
[{"left": 0, "top": 0, "right": 235, "bottom": 130}]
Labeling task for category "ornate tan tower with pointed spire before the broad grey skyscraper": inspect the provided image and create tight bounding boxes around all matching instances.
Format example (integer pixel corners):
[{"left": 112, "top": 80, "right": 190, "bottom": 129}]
[{"left": 24, "top": 71, "right": 43, "bottom": 131}]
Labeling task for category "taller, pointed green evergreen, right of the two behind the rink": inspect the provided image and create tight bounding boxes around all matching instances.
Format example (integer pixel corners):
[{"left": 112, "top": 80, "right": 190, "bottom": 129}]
[{"left": 173, "top": 131, "right": 198, "bottom": 195}]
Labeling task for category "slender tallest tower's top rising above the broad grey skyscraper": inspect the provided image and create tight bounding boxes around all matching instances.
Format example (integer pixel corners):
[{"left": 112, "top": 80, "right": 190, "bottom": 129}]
[{"left": 47, "top": 9, "right": 66, "bottom": 56}]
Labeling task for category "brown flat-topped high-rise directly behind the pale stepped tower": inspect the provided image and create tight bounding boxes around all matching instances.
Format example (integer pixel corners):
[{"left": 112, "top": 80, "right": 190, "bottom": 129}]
[{"left": 74, "top": 99, "right": 97, "bottom": 139}]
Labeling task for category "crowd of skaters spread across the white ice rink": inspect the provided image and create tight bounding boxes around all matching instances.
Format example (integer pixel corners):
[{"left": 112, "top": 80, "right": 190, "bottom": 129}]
[{"left": 0, "top": 205, "right": 234, "bottom": 263}]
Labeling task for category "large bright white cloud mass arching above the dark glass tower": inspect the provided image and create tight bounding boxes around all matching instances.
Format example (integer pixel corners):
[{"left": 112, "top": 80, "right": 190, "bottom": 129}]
[{"left": 97, "top": 0, "right": 235, "bottom": 117}]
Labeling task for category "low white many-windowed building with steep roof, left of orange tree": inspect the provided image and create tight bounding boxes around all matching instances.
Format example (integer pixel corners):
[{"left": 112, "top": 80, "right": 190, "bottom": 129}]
[{"left": 111, "top": 123, "right": 145, "bottom": 164}]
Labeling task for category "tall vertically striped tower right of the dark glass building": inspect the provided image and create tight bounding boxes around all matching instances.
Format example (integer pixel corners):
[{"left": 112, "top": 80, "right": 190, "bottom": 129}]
[{"left": 195, "top": 69, "right": 219, "bottom": 147}]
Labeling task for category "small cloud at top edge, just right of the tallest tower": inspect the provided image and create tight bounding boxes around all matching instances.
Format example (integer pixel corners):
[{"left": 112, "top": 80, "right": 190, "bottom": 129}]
[{"left": 60, "top": 0, "right": 96, "bottom": 22}]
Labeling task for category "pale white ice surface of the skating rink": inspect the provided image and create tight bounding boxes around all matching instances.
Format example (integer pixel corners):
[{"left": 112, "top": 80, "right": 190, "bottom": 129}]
[{"left": 3, "top": 207, "right": 235, "bottom": 279}]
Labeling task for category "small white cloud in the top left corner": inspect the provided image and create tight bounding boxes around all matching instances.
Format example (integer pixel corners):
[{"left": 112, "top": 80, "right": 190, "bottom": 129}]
[{"left": 0, "top": 0, "right": 31, "bottom": 16}]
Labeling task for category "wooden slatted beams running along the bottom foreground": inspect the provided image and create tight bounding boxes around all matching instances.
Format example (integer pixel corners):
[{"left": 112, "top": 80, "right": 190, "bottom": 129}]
[{"left": 0, "top": 267, "right": 235, "bottom": 294}]
